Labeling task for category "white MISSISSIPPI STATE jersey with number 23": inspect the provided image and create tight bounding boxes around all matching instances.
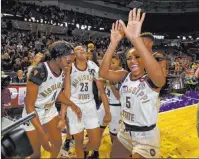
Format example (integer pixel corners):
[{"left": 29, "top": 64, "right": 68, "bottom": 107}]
[{"left": 70, "top": 61, "right": 99, "bottom": 104}]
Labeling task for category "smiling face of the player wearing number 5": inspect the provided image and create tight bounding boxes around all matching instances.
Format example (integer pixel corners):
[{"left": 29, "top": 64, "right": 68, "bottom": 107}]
[{"left": 126, "top": 48, "right": 145, "bottom": 77}]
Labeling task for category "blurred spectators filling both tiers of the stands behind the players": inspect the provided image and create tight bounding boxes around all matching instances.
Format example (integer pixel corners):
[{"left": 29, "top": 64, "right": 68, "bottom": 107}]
[{"left": 1, "top": 0, "right": 199, "bottom": 83}]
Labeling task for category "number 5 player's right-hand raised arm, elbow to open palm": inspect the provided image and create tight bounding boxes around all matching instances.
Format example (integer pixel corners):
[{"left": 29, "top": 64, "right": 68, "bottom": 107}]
[{"left": 119, "top": 8, "right": 165, "bottom": 87}]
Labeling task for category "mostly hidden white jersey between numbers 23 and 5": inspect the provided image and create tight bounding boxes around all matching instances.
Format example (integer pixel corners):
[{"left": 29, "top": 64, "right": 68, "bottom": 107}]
[{"left": 105, "top": 82, "right": 120, "bottom": 105}]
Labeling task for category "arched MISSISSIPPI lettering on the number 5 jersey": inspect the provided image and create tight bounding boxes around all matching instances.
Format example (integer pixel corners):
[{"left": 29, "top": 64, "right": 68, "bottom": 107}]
[{"left": 122, "top": 83, "right": 150, "bottom": 103}]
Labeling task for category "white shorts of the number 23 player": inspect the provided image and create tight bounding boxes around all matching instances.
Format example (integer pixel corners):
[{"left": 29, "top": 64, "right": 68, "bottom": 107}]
[{"left": 67, "top": 99, "right": 100, "bottom": 135}]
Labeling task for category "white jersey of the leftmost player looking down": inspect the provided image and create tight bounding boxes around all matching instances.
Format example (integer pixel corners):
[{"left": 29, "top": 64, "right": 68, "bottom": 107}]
[{"left": 35, "top": 62, "right": 64, "bottom": 109}]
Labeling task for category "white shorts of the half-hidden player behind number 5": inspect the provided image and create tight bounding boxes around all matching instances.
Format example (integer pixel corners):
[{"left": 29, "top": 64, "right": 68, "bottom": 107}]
[{"left": 97, "top": 104, "right": 121, "bottom": 134}]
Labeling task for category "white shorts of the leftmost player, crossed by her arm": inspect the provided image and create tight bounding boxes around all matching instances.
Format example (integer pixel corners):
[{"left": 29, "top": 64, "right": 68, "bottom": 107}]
[{"left": 21, "top": 106, "right": 58, "bottom": 131}]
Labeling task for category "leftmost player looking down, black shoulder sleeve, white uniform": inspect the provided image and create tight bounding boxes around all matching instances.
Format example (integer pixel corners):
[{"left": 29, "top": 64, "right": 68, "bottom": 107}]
[{"left": 22, "top": 41, "right": 81, "bottom": 158}]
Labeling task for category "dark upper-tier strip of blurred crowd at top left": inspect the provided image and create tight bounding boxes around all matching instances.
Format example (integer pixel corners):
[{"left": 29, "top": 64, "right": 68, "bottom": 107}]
[{"left": 1, "top": 0, "right": 114, "bottom": 30}]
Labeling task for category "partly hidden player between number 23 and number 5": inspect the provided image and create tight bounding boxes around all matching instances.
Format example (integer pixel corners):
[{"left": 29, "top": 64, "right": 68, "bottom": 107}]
[{"left": 90, "top": 55, "right": 121, "bottom": 159}]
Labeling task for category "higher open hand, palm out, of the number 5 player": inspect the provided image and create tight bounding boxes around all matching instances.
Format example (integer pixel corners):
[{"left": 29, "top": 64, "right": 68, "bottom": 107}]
[{"left": 119, "top": 8, "right": 145, "bottom": 41}]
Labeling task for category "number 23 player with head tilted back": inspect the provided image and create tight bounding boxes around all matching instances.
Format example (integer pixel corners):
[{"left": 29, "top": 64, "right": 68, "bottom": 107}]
[{"left": 59, "top": 46, "right": 111, "bottom": 158}]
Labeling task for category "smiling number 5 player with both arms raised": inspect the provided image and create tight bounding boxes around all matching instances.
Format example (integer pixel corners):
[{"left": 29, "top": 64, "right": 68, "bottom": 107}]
[{"left": 100, "top": 8, "right": 165, "bottom": 158}]
